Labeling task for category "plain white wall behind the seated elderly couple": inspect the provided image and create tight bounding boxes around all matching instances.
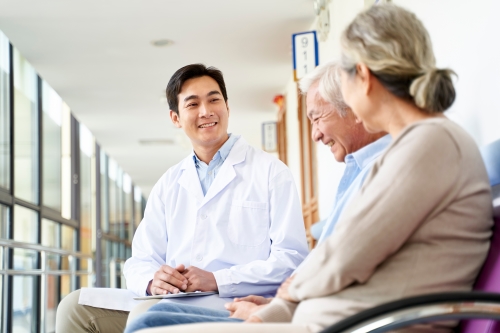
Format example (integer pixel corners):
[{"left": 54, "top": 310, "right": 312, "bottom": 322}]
[{"left": 285, "top": 0, "right": 500, "bottom": 219}]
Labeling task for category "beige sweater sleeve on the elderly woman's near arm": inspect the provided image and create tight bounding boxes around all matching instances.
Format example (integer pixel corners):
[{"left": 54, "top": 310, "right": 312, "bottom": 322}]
[{"left": 289, "top": 124, "right": 461, "bottom": 301}]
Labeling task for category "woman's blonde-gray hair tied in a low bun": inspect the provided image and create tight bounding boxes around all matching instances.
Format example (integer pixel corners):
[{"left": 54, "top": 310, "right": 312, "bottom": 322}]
[{"left": 341, "top": 4, "right": 455, "bottom": 113}]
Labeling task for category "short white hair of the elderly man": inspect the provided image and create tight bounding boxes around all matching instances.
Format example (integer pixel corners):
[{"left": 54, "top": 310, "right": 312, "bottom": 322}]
[{"left": 299, "top": 61, "right": 350, "bottom": 117}]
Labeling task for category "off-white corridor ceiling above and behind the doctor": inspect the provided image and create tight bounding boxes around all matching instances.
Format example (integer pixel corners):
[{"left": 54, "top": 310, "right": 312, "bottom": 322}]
[{"left": 0, "top": 0, "right": 314, "bottom": 195}]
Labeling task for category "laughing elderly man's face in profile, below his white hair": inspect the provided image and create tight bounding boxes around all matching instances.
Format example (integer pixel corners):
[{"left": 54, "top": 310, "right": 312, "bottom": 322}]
[{"left": 306, "top": 83, "right": 362, "bottom": 162}]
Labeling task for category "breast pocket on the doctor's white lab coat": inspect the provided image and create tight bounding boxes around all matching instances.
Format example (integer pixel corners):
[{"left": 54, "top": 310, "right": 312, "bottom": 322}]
[{"left": 227, "top": 200, "right": 269, "bottom": 246}]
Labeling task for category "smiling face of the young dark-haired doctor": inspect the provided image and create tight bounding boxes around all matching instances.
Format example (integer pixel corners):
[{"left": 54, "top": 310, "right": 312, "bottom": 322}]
[{"left": 170, "top": 76, "right": 229, "bottom": 150}]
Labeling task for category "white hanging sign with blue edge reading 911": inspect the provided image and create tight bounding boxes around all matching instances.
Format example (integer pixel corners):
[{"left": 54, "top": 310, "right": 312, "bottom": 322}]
[{"left": 292, "top": 31, "right": 319, "bottom": 81}]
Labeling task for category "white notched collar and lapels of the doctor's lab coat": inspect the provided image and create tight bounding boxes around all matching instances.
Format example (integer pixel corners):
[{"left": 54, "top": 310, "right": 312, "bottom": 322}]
[{"left": 178, "top": 137, "right": 248, "bottom": 208}]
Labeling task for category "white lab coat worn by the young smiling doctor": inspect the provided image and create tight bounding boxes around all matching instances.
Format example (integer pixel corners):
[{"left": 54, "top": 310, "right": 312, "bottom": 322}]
[{"left": 124, "top": 138, "right": 308, "bottom": 297}]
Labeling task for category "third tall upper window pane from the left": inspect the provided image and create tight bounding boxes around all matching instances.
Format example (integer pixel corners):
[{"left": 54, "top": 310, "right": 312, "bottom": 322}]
[{"left": 42, "top": 81, "right": 63, "bottom": 212}]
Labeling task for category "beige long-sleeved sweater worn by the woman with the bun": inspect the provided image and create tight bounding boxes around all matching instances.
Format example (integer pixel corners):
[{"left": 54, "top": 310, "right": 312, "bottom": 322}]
[{"left": 256, "top": 118, "right": 493, "bottom": 331}]
